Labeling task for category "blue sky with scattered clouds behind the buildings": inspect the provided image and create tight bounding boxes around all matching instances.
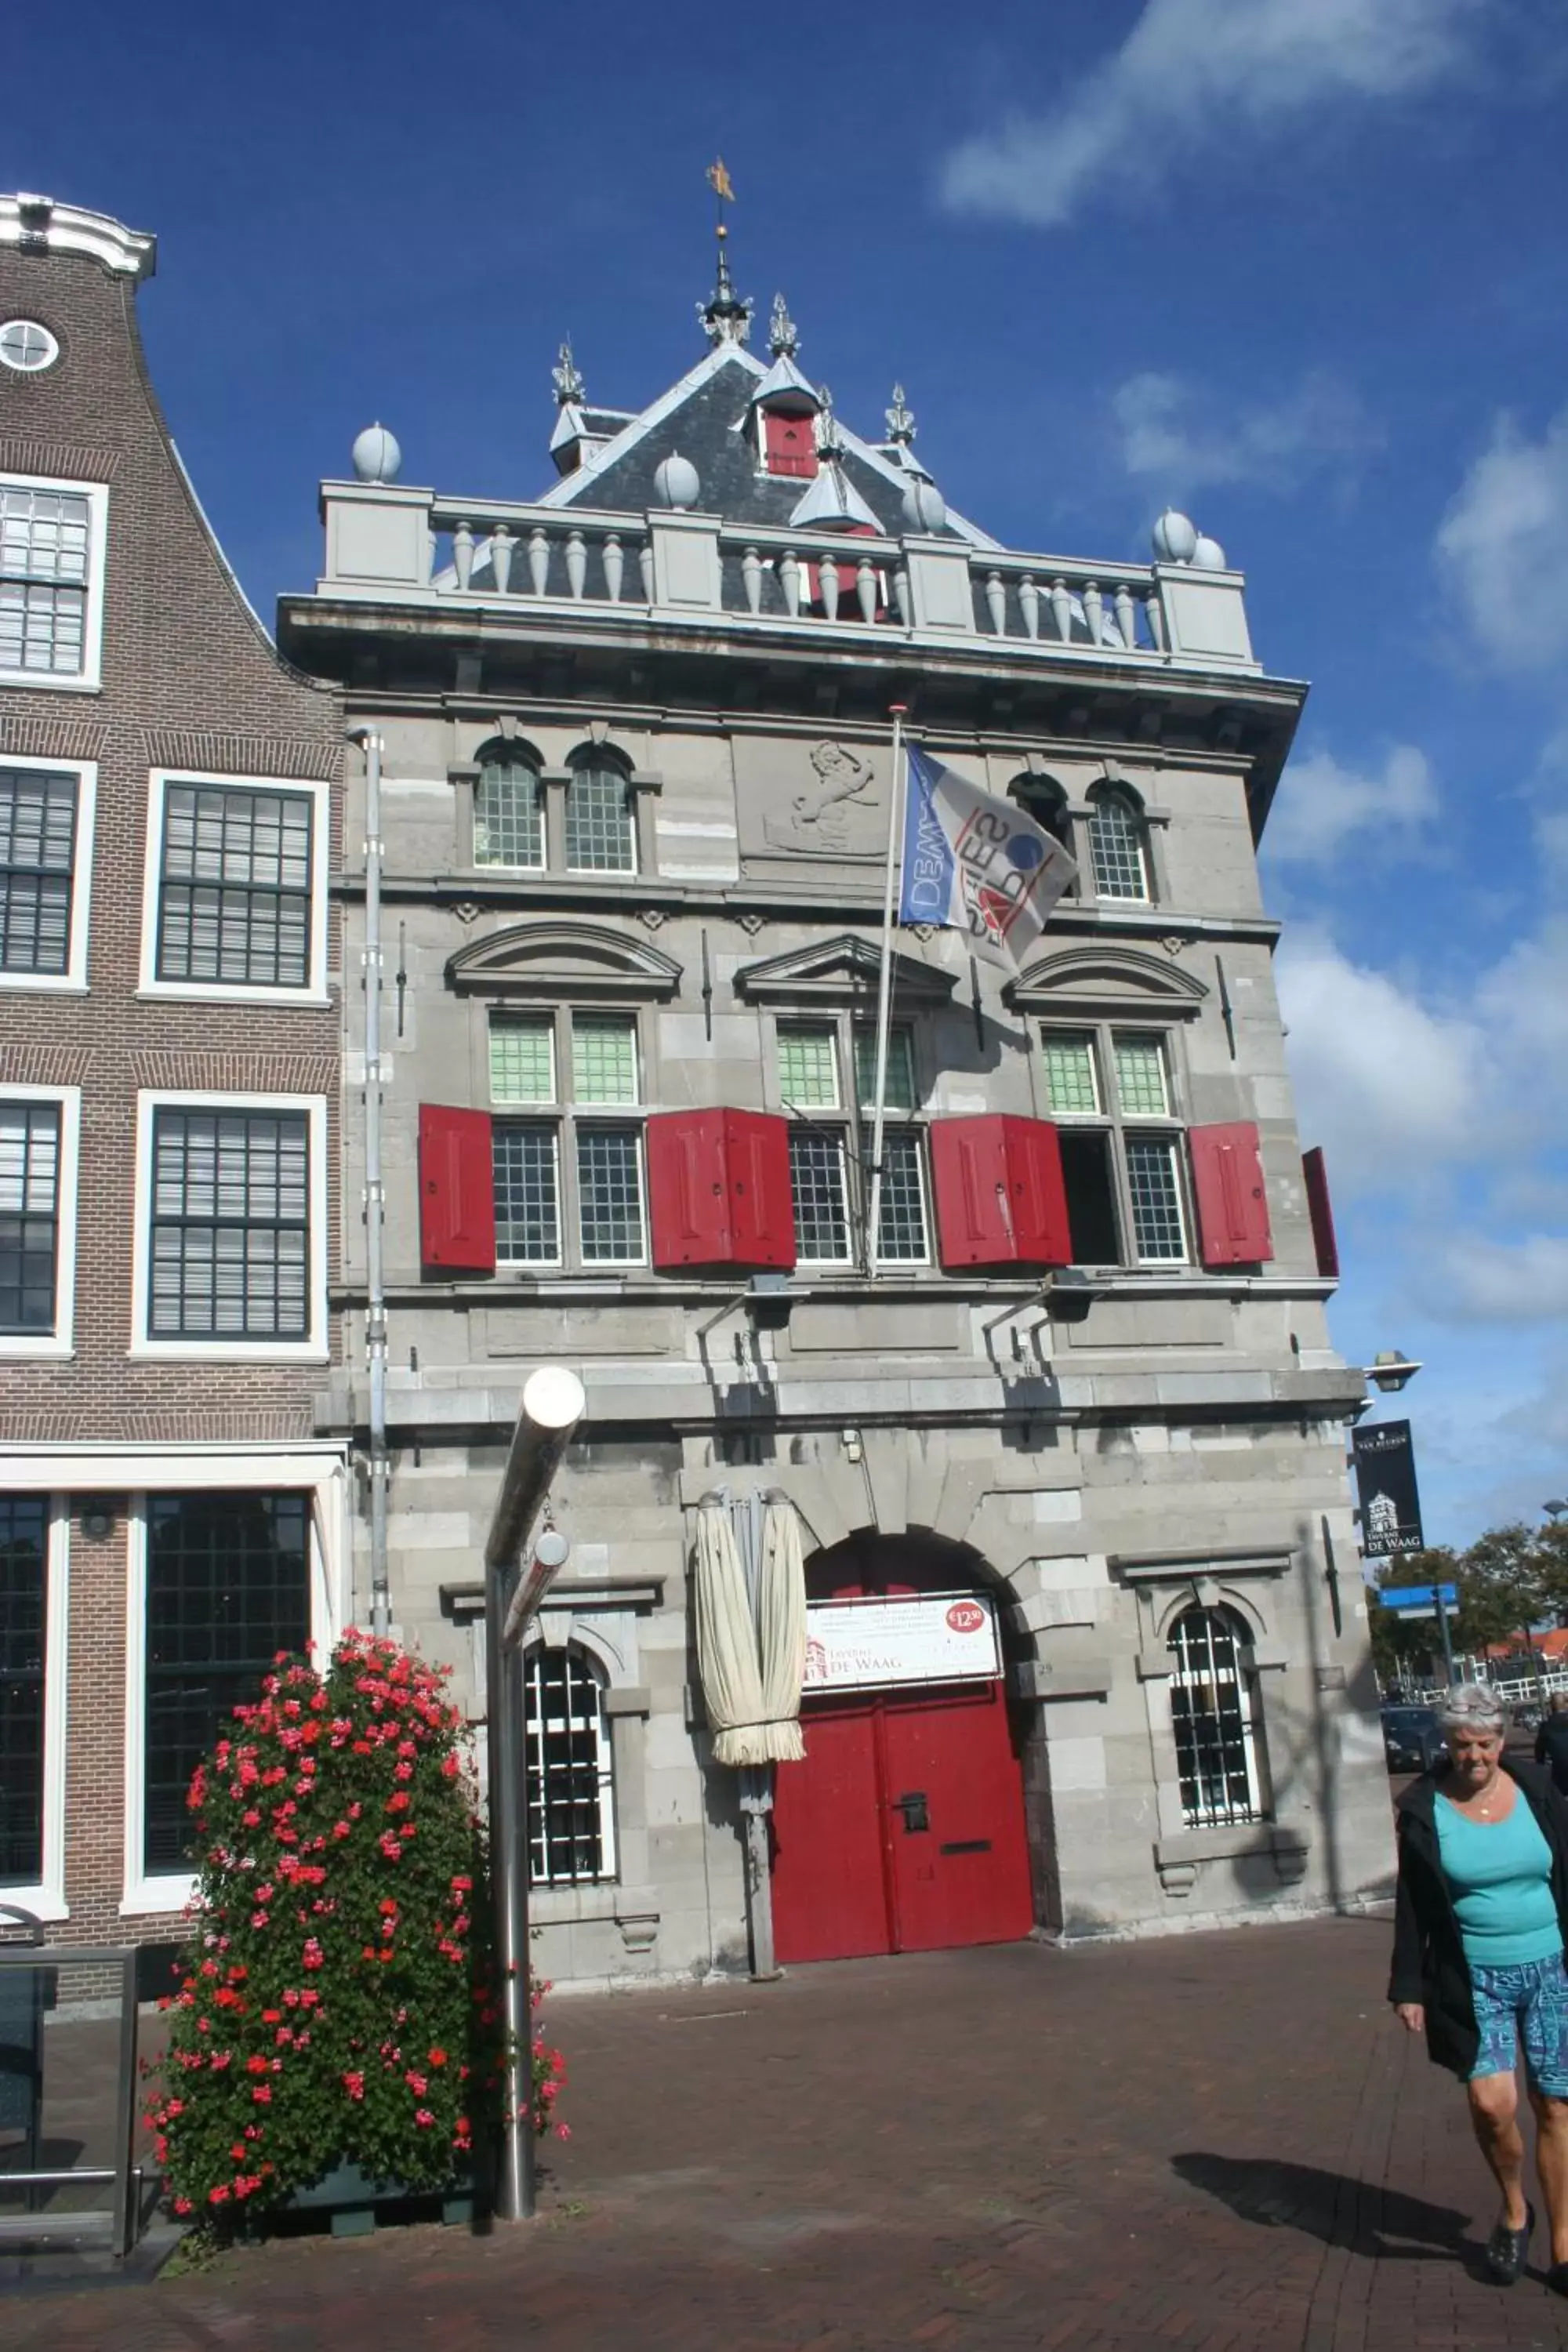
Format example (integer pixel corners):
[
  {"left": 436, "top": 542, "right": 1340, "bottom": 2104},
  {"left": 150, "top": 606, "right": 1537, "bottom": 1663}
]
[{"left": 12, "top": 0, "right": 1568, "bottom": 1541}]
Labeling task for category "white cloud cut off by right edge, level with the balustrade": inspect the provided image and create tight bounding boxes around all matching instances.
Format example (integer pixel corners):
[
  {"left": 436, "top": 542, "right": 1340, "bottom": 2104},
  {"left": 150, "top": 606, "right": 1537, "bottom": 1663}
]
[{"left": 1436, "top": 409, "right": 1568, "bottom": 670}]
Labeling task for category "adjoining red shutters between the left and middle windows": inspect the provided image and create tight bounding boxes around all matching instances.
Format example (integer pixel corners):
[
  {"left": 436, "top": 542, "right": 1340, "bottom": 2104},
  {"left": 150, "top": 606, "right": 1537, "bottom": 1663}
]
[{"left": 647, "top": 1110, "right": 794, "bottom": 1272}]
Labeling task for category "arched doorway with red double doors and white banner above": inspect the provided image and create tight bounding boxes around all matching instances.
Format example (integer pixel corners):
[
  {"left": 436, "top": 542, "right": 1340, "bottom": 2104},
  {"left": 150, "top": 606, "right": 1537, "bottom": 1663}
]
[{"left": 774, "top": 1536, "right": 1034, "bottom": 1962}]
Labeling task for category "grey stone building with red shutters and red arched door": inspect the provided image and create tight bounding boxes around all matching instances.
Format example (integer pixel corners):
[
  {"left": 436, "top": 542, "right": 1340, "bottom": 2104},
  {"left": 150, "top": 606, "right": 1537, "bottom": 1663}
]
[{"left": 280, "top": 273, "right": 1389, "bottom": 1983}]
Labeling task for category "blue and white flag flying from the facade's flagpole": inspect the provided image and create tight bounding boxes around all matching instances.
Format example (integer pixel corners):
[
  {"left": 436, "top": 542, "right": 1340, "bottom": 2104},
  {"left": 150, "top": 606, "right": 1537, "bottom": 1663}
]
[{"left": 898, "top": 746, "right": 1076, "bottom": 971}]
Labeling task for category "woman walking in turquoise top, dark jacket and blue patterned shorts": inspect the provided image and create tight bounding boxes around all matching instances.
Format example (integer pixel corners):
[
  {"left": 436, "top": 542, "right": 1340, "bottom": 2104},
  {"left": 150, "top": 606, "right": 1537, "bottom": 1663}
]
[{"left": 1389, "top": 1682, "right": 1568, "bottom": 2296}]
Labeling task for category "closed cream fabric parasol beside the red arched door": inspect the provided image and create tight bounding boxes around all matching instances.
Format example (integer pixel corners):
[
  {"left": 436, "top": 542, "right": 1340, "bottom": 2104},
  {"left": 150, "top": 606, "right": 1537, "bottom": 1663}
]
[{"left": 696, "top": 1503, "right": 806, "bottom": 1766}]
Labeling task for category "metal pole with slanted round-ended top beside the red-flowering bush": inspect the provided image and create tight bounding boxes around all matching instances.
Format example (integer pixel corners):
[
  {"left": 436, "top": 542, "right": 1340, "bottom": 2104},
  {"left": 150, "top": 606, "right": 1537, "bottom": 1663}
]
[{"left": 485, "top": 1364, "right": 586, "bottom": 2220}]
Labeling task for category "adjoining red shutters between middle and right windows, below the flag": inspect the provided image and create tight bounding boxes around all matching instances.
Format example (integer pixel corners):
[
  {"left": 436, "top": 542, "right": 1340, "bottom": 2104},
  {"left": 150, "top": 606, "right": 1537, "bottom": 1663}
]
[{"left": 931, "top": 1115, "right": 1072, "bottom": 1268}]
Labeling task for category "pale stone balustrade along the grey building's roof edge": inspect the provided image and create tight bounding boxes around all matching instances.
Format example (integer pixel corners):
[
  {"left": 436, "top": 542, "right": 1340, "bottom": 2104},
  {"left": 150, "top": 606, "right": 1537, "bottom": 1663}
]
[{"left": 320, "top": 482, "right": 1258, "bottom": 668}]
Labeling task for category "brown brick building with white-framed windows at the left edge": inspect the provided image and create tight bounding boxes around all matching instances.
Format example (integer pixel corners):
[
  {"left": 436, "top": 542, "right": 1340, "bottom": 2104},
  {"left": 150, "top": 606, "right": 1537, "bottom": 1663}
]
[{"left": 0, "top": 195, "right": 348, "bottom": 1943}]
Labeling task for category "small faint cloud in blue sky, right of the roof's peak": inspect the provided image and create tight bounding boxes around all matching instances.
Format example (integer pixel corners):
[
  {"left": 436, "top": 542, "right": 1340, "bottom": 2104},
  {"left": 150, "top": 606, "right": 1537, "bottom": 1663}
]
[{"left": 1112, "top": 369, "right": 1377, "bottom": 499}]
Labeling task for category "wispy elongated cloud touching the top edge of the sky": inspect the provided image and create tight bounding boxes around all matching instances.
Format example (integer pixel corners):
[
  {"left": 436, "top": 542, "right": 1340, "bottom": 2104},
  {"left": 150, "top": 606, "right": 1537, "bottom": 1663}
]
[{"left": 940, "top": 0, "right": 1488, "bottom": 228}]
